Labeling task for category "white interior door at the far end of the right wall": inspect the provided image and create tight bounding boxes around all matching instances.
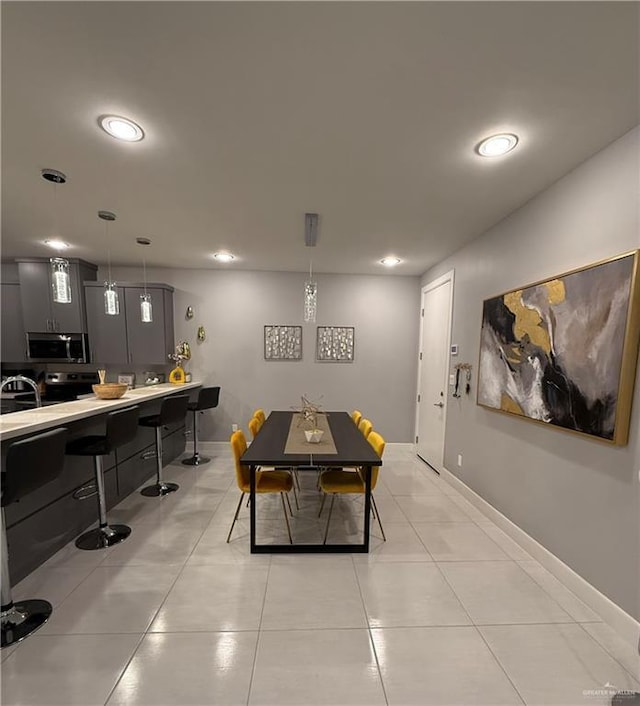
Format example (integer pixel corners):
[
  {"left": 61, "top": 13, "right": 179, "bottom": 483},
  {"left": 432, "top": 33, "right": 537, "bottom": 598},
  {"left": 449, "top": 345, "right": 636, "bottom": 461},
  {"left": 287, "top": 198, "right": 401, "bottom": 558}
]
[{"left": 416, "top": 271, "right": 453, "bottom": 471}]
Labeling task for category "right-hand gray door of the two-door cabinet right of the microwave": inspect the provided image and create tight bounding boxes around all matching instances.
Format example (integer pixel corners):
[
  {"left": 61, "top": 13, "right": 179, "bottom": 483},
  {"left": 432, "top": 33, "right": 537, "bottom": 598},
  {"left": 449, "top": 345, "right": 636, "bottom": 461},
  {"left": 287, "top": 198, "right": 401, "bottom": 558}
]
[{"left": 125, "top": 287, "right": 173, "bottom": 365}]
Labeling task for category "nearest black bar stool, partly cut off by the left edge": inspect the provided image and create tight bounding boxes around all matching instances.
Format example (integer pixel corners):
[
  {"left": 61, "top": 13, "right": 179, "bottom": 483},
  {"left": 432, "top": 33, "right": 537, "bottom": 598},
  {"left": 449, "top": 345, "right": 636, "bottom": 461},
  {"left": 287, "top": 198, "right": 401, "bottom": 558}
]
[{"left": 0, "top": 428, "right": 67, "bottom": 647}]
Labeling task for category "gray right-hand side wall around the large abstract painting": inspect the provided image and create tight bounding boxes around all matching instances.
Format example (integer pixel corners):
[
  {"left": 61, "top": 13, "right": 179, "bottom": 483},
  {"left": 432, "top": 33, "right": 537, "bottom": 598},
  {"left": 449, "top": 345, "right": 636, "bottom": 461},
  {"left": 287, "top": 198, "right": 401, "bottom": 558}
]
[{"left": 422, "top": 129, "right": 640, "bottom": 618}]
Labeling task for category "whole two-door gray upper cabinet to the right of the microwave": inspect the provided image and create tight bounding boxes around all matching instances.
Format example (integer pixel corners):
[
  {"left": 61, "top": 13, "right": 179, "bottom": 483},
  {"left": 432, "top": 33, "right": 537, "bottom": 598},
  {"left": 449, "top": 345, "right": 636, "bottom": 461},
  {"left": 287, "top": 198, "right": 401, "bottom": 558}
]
[{"left": 85, "top": 282, "right": 175, "bottom": 365}]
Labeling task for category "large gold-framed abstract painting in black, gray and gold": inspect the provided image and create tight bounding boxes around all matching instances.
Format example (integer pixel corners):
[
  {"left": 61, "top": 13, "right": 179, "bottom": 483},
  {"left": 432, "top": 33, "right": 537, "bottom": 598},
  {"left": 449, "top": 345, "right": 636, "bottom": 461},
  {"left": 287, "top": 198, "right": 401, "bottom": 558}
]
[{"left": 478, "top": 251, "right": 640, "bottom": 445}]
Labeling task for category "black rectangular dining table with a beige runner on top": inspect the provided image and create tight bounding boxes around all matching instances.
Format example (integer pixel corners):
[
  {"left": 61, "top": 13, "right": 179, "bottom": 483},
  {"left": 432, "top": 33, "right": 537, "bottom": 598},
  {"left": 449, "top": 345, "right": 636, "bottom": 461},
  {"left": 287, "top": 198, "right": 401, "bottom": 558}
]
[{"left": 240, "top": 411, "right": 382, "bottom": 554}]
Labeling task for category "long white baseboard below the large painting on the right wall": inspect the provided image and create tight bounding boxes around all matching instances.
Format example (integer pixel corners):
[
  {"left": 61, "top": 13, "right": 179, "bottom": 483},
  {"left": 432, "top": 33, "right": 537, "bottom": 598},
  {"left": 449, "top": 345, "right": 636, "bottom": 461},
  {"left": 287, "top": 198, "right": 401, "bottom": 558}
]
[{"left": 440, "top": 467, "right": 640, "bottom": 648}]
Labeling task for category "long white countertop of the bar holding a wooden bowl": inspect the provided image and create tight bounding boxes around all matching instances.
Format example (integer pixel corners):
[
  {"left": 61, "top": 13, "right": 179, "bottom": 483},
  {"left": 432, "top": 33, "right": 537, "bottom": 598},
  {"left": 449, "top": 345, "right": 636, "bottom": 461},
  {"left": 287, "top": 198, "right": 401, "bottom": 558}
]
[{"left": 0, "top": 382, "right": 202, "bottom": 441}]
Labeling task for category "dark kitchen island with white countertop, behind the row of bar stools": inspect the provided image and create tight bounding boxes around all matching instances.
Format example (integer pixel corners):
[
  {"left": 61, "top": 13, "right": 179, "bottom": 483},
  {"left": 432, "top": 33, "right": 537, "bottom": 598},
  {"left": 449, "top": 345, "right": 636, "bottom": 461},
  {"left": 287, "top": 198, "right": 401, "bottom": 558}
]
[{"left": 0, "top": 382, "right": 201, "bottom": 583}]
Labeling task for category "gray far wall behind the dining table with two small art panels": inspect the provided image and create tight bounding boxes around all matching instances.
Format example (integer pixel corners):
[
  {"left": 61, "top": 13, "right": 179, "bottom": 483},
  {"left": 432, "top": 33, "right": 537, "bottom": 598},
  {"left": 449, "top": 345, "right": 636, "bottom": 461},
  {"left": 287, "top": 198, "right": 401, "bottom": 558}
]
[{"left": 107, "top": 265, "right": 420, "bottom": 442}]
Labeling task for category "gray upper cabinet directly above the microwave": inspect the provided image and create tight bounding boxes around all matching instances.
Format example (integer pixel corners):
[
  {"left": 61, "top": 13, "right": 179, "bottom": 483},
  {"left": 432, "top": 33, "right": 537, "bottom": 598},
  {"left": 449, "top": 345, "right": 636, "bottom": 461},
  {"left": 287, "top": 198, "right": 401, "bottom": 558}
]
[{"left": 16, "top": 257, "right": 98, "bottom": 333}]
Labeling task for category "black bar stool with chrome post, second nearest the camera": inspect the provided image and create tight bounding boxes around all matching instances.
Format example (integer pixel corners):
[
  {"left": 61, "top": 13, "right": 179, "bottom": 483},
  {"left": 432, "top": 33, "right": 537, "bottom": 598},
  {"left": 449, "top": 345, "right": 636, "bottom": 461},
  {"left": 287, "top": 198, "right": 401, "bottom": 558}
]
[{"left": 67, "top": 407, "right": 139, "bottom": 550}]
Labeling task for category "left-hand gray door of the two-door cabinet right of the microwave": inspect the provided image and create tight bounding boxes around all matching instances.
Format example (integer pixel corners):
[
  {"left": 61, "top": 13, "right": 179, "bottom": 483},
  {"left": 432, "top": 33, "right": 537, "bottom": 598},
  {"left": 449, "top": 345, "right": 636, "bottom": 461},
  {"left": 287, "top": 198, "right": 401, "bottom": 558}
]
[{"left": 84, "top": 287, "right": 129, "bottom": 367}]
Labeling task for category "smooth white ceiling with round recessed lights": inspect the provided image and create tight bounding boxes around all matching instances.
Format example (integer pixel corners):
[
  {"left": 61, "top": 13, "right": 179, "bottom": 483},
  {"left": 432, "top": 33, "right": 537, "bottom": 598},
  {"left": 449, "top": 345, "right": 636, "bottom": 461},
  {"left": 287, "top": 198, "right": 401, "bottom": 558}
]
[{"left": 2, "top": 1, "right": 639, "bottom": 275}]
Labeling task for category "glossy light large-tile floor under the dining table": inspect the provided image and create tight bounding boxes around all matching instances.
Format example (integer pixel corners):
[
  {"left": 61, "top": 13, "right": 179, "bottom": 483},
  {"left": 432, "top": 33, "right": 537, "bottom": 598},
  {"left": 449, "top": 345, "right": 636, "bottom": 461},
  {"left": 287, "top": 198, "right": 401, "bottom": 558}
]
[{"left": 1, "top": 444, "right": 640, "bottom": 706}]
